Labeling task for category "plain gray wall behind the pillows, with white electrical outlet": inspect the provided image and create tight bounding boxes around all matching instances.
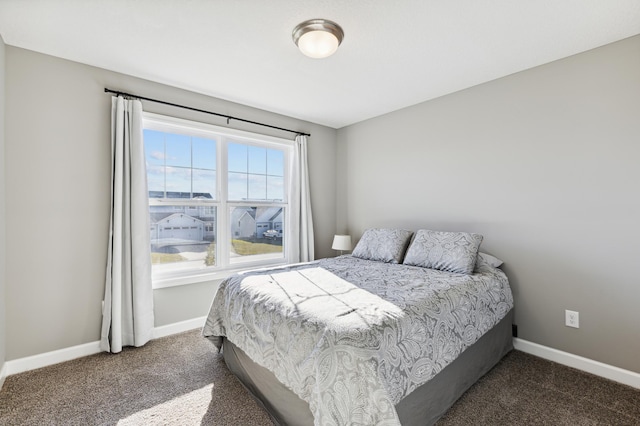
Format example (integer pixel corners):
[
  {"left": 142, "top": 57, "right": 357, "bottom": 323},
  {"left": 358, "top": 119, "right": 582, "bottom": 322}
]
[{"left": 337, "top": 36, "right": 640, "bottom": 372}]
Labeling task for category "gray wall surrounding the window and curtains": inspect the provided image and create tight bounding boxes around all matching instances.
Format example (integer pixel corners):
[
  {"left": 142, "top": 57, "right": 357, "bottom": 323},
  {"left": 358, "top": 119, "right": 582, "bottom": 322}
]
[{"left": 6, "top": 46, "right": 337, "bottom": 360}]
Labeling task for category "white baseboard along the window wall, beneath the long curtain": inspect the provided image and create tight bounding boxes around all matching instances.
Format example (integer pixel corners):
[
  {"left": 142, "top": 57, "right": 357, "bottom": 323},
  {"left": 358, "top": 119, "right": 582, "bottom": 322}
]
[{"left": 0, "top": 317, "right": 206, "bottom": 382}]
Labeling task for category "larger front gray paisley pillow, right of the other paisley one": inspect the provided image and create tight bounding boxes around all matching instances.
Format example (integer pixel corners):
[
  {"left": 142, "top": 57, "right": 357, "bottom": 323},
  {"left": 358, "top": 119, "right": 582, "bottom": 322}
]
[{"left": 403, "top": 229, "right": 482, "bottom": 274}]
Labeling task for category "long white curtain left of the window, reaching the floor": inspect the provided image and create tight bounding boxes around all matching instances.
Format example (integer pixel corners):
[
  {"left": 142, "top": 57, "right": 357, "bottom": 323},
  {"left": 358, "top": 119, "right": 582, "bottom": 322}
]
[{"left": 100, "top": 96, "right": 154, "bottom": 353}]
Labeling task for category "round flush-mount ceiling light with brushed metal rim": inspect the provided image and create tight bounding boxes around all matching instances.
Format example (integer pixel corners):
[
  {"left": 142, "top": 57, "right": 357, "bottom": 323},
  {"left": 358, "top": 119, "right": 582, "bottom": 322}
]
[{"left": 292, "top": 19, "right": 344, "bottom": 59}]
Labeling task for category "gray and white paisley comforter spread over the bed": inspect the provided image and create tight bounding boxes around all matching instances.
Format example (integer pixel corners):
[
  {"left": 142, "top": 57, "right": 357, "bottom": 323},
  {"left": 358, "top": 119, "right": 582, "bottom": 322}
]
[{"left": 203, "top": 256, "right": 513, "bottom": 425}]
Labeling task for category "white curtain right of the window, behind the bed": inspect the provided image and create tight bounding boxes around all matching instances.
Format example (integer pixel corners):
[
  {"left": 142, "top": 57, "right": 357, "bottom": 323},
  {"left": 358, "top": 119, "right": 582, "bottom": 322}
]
[{"left": 287, "top": 135, "right": 314, "bottom": 263}]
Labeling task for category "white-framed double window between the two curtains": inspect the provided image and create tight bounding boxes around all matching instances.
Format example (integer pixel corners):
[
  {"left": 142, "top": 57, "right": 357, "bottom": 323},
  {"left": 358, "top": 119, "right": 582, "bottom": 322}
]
[{"left": 143, "top": 113, "right": 293, "bottom": 287}]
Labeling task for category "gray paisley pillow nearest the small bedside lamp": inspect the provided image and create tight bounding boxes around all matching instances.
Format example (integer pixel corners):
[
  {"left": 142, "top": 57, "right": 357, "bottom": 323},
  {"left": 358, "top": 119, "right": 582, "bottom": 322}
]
[{"left": 351, "top": 228, "right": 413, "bottom": 263}]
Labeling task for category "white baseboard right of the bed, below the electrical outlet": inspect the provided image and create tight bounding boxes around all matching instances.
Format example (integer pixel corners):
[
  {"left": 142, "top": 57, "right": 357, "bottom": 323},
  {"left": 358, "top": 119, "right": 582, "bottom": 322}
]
[{"left": 513, "top": 337, "right": 640, "bottom": 389}]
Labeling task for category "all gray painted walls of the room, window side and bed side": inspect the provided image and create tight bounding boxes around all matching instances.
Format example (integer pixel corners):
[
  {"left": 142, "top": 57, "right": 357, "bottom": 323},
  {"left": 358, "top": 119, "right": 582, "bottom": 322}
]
[{"left": 0, "top": 32, "right": 640, "bottom": 372}]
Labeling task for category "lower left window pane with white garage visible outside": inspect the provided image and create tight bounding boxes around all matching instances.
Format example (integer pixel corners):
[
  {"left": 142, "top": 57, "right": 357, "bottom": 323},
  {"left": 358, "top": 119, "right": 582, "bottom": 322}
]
[{"left": 149, "top": 205, "right": 216, "bottom": 267}]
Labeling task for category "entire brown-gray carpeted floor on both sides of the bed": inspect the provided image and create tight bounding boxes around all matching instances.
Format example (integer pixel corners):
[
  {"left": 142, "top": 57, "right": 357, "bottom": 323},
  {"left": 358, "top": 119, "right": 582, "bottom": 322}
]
[{"left": 0, "top": 330, "right": 640, "bottom": 426}]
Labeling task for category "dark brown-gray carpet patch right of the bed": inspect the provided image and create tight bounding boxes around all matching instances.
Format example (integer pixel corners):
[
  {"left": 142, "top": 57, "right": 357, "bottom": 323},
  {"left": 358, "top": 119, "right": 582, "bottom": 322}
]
[{"left": 437, "top": 351, "right": 640, "bottom": 426}]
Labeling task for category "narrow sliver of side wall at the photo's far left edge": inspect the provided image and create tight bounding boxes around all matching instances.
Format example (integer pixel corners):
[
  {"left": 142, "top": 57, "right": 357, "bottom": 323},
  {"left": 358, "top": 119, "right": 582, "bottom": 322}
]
[{"left": 0, "top": 35, "right": 6, "bottom": 371}]
